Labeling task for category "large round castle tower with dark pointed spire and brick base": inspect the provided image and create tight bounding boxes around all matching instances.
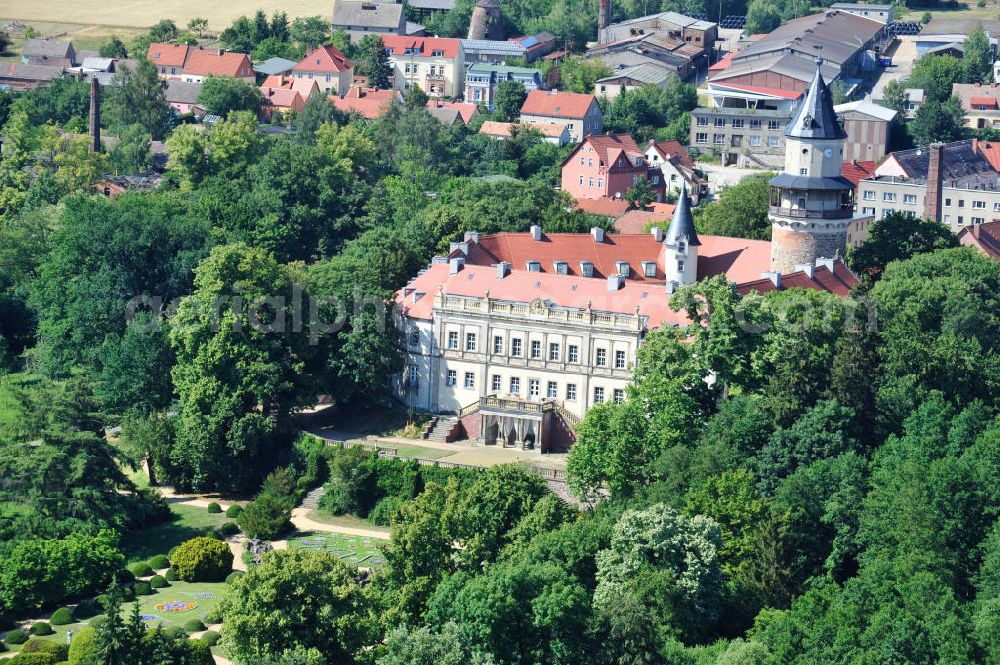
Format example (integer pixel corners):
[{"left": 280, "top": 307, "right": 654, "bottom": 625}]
[{"left": 768, "top": 59, "right": 854, "bottom": 273}]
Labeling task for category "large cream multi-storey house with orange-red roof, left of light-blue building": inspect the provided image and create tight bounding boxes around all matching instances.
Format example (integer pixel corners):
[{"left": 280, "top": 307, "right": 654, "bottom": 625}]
[{"left": 382, "top": 35, "right": 465, "bottom": 97}]
